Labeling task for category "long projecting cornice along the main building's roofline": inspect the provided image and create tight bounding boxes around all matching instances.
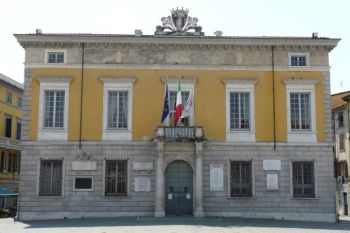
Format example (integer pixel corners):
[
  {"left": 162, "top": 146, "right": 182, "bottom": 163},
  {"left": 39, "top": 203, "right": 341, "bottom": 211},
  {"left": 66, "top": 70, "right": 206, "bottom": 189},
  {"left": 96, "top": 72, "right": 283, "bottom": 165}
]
[{"left": 14, "top": 34, "right": 340, "bottom": 50}]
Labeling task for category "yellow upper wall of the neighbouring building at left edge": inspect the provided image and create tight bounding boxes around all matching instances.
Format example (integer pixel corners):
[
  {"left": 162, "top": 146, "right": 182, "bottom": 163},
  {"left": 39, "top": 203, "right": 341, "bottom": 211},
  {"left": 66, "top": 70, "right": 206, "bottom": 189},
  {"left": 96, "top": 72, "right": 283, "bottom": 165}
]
[{"left": 0, "top": 82, "right": 23, "bottom": 138}]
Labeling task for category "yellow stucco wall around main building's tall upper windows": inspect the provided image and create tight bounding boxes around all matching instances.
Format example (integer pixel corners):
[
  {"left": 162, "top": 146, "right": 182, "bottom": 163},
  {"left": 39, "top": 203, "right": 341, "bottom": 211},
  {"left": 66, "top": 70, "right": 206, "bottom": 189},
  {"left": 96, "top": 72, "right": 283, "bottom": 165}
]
[{"left": 30, "top": 69, "right": 325, "bottom": 142}]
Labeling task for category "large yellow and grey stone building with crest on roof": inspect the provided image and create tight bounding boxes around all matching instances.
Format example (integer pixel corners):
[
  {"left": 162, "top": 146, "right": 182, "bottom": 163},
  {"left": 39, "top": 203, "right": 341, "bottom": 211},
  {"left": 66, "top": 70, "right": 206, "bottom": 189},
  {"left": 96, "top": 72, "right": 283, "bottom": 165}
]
[{"left": 15, "top": 9, "right": 339, "bottom": 221}]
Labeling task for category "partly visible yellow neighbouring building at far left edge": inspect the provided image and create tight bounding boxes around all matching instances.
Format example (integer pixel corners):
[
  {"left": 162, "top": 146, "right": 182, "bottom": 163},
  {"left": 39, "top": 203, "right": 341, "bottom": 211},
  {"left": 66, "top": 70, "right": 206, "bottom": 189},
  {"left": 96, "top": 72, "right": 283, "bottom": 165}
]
[{"left": 0, "top": 74, "right": 23, "bottom": 190}]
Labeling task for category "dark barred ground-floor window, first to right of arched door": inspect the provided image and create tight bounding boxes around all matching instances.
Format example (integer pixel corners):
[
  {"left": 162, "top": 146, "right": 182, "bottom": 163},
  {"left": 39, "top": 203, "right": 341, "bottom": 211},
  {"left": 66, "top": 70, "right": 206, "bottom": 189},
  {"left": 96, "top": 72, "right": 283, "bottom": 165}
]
[{"left": 230, "top": 161, "right": 253, "bottom": 197}]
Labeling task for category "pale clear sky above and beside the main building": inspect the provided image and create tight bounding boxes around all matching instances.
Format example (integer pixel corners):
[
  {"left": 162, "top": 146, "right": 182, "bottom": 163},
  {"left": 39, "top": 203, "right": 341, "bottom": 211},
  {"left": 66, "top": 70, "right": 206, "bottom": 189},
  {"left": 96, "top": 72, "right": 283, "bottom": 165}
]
[{"left": 0, "top": 0, "right": 350, "bottom": 93}]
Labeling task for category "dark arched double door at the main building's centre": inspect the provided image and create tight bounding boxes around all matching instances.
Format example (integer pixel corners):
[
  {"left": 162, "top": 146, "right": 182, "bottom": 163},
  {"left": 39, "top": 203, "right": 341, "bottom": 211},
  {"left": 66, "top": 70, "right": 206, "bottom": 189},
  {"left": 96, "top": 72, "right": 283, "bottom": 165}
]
[{"left": 165, "top": 160, "right": 193, "bottom": 215}]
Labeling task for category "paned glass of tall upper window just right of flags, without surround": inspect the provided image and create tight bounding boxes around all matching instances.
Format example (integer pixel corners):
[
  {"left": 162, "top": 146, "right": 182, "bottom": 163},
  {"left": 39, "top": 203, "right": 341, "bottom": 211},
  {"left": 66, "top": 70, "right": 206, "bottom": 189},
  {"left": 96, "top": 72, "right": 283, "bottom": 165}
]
[{"left": 230, "top": 92, "right": 250, "bottom": 130}]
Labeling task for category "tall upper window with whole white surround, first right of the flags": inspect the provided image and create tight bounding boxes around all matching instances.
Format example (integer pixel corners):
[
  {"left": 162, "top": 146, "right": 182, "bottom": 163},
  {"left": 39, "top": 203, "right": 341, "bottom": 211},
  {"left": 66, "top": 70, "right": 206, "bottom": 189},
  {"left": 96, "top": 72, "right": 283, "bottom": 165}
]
[{"left": 222, "top": 78, "right": 257, "bottom": 142}]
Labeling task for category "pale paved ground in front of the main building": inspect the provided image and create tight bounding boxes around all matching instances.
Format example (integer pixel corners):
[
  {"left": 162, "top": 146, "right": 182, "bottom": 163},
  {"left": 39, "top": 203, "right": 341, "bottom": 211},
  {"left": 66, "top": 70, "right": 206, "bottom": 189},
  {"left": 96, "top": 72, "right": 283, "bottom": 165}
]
[{"left": 0, "top": 217, "right": 350, "bottom": 233}]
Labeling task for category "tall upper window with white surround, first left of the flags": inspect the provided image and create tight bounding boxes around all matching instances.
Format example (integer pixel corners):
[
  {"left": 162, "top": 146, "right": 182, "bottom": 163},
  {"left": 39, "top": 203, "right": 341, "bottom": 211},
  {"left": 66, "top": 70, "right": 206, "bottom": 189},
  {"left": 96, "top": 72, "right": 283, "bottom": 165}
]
[{"left": 100, "top": 77, "right": 136, "bottom": 141}]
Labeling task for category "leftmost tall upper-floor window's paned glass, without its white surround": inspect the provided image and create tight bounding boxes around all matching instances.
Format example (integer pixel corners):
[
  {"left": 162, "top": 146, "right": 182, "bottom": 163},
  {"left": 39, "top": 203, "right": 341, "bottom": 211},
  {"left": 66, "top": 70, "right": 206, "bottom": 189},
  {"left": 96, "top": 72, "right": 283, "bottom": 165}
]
[{"left": 44, "top": 90, "right": 65, "bottom": 128}]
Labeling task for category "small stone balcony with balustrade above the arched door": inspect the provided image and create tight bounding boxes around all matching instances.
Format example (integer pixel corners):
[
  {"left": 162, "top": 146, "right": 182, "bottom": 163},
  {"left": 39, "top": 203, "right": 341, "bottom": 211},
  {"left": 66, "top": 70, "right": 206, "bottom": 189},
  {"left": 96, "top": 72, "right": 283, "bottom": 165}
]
[{"left": 156, "top": 126, "right": 204, "bottom": 142}]
